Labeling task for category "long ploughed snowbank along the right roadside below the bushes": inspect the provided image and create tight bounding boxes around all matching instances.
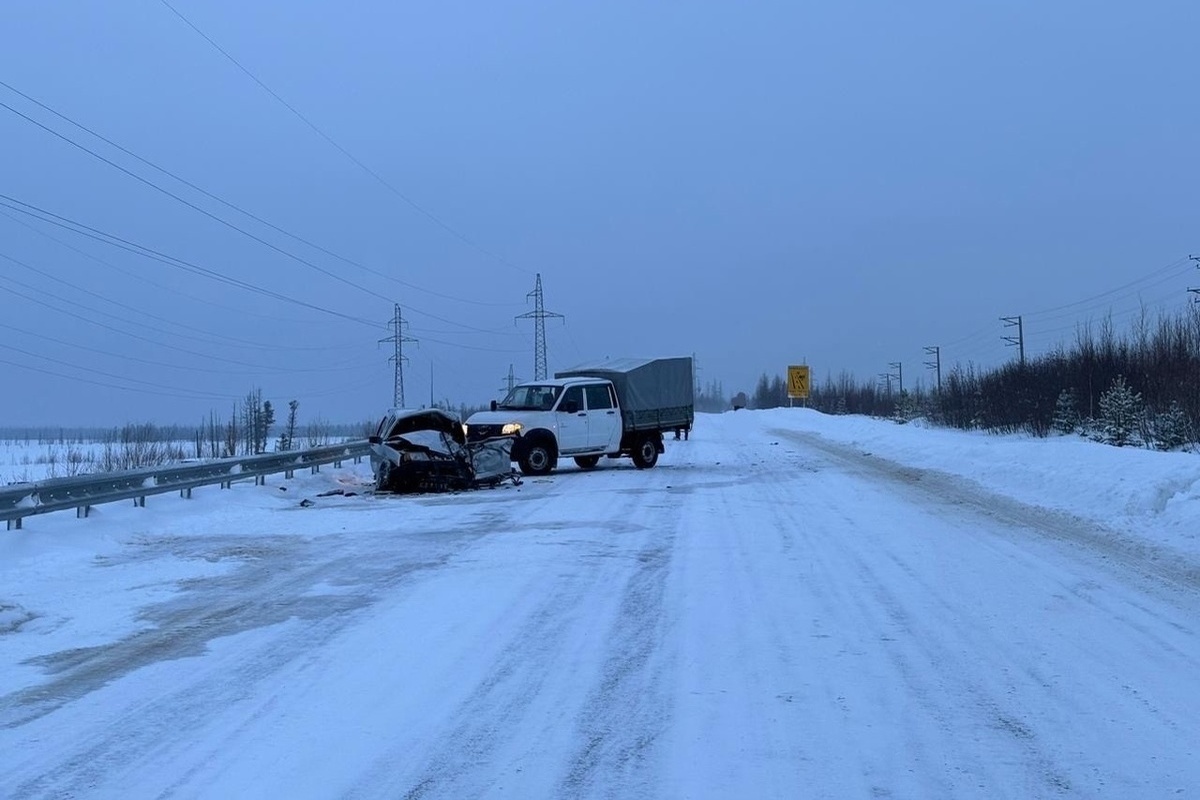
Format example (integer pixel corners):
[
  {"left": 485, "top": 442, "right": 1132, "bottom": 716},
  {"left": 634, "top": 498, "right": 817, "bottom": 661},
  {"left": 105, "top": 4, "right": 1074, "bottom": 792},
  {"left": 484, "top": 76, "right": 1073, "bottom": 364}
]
[{"left": 727, "top": 409, "right": 1200, "bottom": 555}]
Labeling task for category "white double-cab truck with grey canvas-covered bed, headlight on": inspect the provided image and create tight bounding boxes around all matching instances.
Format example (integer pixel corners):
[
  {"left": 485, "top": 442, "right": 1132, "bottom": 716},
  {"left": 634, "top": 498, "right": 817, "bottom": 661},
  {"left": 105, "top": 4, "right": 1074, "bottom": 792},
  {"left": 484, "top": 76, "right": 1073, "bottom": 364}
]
[{"left": 467, "top": 357, "right": 695, "bottom": 475}]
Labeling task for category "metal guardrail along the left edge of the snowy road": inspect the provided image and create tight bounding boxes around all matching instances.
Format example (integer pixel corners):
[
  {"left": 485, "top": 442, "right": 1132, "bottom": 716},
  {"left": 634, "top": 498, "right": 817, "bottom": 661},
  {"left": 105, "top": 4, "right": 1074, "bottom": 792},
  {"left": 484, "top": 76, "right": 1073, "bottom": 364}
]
[{"left": 0, "top": 440, "right": 371, "bottom": 530}]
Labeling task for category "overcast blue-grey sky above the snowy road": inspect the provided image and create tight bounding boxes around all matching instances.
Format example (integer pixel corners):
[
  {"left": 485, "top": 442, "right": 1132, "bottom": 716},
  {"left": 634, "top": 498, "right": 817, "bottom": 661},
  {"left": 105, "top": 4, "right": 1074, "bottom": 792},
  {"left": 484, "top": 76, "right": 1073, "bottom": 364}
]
[{"left": 0, "top": 0, "right": 1200, "bottom": 425}]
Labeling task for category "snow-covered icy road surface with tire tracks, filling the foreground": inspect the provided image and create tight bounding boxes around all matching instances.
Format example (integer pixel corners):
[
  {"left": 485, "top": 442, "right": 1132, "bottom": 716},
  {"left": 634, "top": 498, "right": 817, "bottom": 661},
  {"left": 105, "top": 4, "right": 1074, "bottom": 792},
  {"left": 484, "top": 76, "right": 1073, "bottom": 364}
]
[{"left": 0, "top": 413, "right": 1200, "bottom": 800}]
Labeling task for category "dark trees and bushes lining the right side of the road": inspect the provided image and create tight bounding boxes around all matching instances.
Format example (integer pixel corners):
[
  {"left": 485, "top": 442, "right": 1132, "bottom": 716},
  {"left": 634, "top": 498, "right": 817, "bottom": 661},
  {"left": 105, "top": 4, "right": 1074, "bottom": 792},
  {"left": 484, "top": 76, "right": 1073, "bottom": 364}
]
[{"left": 751, "top": 306, "right": 1200, "bottom": 449}]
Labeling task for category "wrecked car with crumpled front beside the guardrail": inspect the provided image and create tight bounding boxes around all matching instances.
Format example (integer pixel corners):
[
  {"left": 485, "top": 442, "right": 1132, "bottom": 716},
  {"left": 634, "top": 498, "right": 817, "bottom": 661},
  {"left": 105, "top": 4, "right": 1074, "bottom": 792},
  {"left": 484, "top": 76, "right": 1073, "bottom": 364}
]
[{"left": 367, "top": 408, "right": 516, "bottom": 493}]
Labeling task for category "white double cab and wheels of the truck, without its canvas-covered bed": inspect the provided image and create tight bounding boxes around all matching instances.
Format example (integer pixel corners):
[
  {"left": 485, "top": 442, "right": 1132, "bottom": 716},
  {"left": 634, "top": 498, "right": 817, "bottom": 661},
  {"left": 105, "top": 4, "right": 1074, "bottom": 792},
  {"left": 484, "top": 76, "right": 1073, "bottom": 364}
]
[{"left": 467, "top": 378, "right": 662, "bottom": 475}]
